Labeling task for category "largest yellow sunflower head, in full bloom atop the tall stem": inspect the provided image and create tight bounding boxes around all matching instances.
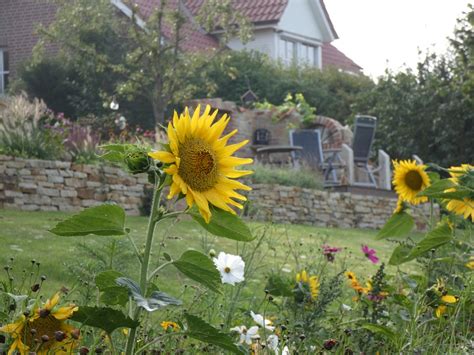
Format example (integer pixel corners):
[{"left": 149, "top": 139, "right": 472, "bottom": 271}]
[{"left": 150, "top": 106, "right": 253, "bottom": 223}]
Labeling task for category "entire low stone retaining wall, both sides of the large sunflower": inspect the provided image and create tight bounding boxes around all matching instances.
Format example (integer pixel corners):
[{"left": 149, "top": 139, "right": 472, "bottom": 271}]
[{"left": 0, "top": 156, "right": 428, "bottom": 229}]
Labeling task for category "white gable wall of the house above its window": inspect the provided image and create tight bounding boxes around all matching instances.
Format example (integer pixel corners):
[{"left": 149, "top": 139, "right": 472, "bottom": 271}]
[{"left": 278, "top": 0, "right": 324, "bottom": 42}]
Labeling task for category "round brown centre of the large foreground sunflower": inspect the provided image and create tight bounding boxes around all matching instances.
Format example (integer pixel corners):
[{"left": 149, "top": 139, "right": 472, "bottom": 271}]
[{"left": 178, "top": 138, "right": 218, "bottom": 191}]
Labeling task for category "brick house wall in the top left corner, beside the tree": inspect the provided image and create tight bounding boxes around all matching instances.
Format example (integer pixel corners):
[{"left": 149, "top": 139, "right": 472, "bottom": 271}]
[{"left": 0, "top": 0, "right": 57, "bottom": 79}]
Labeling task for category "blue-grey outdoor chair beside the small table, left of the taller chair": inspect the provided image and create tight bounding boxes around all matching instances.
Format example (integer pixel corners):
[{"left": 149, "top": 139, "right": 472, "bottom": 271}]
[{"left": 290, "top": 129, "right": 344, "bottom": 187}]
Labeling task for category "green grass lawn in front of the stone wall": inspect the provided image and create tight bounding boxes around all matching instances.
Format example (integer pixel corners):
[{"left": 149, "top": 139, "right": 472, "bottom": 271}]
[{"left": 0, "top": 210, "right": 412, "bottom": 294}]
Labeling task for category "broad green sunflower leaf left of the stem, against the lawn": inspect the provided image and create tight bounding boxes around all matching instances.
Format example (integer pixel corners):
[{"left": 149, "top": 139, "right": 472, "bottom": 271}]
[{"left": 50, "top": 204, "right": 126, "bottom": 237}]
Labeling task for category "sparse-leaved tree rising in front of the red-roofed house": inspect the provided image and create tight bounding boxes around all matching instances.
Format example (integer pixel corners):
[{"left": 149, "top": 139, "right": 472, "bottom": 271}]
[{"left": 36, "top": 0, "right": 252, "bottom": 131}]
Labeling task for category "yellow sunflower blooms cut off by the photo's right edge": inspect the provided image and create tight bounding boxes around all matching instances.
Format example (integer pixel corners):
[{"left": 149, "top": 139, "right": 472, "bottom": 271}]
[{"left": 445, "top": 164, "right": 474, "bottom": 222}]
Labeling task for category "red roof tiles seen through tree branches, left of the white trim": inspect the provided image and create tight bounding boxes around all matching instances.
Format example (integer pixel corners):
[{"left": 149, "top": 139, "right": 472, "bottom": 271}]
[{"left": 133, "top": 0, "right": 219, "bottom": 51}]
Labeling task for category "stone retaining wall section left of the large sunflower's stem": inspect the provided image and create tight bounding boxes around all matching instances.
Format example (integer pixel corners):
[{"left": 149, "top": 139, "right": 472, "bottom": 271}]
[{"left": 0, "top": 156, "right": 147, "bottom": 215}]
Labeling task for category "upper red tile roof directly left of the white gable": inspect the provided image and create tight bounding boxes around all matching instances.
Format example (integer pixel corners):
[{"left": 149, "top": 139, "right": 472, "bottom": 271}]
[{"left": 184, "top": 0, "right": 288, "bottom": 23}]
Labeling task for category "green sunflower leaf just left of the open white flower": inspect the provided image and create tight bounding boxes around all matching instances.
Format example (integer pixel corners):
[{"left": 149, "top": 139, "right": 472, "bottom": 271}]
[{"left": 173, "top": 250, "right": 222, "bottom": 293}]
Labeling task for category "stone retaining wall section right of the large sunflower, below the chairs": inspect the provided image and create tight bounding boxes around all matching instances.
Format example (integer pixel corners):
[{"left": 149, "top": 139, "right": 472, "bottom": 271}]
[{"left": 249, "top": 184, "right": 429, "bottom": 230}]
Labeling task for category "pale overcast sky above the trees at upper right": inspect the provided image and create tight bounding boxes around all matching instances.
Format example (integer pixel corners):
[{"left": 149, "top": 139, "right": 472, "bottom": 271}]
[{"left": 324, "top": 0, "right": 472, "bottom": 78}]
